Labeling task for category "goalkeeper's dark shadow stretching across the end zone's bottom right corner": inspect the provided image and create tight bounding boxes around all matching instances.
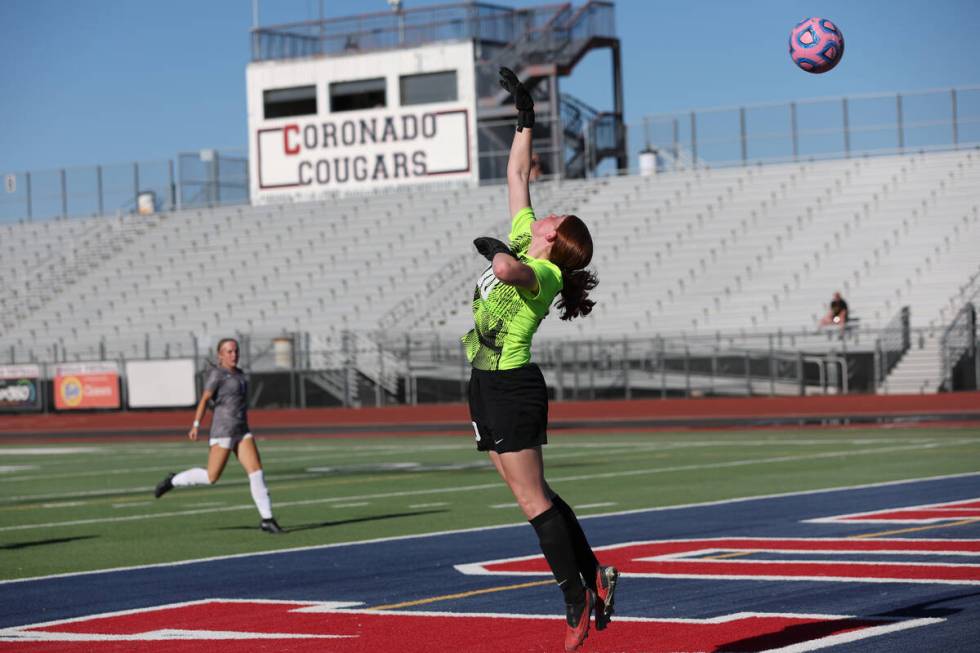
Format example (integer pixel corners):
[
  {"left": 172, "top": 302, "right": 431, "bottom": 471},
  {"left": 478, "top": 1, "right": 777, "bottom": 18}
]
[{"left": 714, "top": 592, "right": 980, "bottom": 651}]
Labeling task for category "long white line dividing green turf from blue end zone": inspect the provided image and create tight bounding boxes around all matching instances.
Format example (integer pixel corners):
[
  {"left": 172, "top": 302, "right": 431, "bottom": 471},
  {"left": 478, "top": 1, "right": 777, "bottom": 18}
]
[{"left": 0, "top": 472, "right": 980, "bottom": 584}]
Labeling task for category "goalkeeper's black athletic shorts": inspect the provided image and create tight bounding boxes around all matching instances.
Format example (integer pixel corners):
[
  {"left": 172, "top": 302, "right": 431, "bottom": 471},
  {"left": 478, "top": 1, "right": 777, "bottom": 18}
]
[{"left": 469, "top": 363, "right": 548, "bottom": 453}]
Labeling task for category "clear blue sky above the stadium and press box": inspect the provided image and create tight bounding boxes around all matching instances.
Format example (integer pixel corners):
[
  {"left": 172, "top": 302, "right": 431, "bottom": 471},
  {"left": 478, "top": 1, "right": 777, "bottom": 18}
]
[{"left": 0, "top": 0, "right": 980, "bottom": 173}]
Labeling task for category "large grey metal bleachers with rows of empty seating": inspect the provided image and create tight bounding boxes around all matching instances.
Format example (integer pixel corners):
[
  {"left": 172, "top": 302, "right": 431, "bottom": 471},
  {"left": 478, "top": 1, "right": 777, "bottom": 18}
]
[{"left": 0, "top": 150, "right": 980, "bottom": 389}]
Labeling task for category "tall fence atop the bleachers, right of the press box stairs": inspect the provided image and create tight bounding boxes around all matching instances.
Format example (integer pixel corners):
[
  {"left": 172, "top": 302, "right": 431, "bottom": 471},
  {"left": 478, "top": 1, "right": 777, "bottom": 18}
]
[{"left": 629, "top": 86, "right": 980, "bottom": 169}]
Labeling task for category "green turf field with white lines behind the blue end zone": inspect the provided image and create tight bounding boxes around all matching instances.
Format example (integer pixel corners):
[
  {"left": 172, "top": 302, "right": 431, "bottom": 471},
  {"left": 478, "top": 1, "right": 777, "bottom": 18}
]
[{"left": 0, "top": 428, "right": 980, "bottom": 579}]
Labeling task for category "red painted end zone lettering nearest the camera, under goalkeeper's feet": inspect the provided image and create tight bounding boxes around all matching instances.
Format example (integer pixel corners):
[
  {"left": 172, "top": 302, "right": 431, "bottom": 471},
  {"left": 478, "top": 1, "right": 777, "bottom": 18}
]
[{"left": 11, "top": 602, "right": 904, "bottom": 653}]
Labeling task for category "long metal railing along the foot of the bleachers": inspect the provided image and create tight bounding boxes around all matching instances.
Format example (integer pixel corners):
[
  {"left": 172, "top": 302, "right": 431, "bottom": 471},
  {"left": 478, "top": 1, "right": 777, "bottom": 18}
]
[{"left": 11, "top": 318, "right": 976, "bottom": 409}]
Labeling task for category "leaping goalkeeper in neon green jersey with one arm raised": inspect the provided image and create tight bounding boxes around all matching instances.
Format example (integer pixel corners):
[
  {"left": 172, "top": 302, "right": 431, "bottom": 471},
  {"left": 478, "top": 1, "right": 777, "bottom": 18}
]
[{"left": 463, "top": 68, "right": 618, "bottom": 651}]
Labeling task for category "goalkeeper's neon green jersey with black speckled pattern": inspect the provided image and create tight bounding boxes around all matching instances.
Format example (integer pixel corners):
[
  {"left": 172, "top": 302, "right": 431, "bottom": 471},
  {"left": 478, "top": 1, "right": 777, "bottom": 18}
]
[{"left": 463, "top": 207, "right": 562, "bottom": 370}]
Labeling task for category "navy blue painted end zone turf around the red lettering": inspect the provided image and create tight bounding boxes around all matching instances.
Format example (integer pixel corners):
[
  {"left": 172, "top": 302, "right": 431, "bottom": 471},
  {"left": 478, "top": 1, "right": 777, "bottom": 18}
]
[{"left": 0, "top": 474, "right": 980, "bottom": 651}]
